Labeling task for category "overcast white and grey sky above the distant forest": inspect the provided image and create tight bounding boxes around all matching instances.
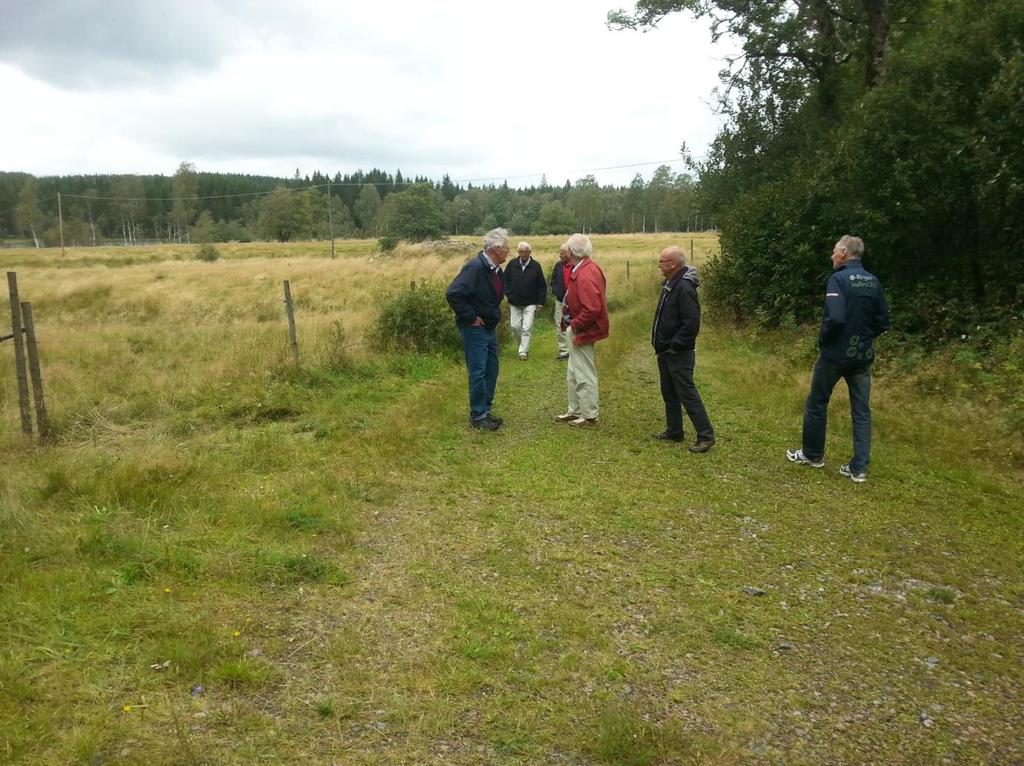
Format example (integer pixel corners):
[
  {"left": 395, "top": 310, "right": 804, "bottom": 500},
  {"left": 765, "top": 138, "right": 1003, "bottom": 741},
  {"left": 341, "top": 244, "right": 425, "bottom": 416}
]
[{"left": 0, "top": 0, "right": 726, "bottom": 186}]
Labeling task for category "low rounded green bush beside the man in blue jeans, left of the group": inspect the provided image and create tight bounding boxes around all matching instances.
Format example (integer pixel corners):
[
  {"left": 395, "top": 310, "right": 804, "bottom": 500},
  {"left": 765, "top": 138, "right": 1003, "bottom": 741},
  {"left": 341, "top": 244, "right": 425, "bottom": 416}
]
[{"left": 371, "top": 283, "right": 462, "bottom": 353}]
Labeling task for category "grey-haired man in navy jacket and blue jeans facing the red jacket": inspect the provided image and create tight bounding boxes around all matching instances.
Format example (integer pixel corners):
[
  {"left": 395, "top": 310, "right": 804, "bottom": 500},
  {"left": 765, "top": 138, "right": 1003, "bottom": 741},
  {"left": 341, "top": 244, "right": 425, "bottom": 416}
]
[{"left": 444, "top": 228, "right": 509, "bottom": 431}]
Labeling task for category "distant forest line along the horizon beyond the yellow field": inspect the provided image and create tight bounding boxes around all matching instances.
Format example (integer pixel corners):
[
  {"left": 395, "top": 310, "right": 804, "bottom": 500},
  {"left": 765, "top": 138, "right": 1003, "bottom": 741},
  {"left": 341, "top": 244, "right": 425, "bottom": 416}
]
[{"left": 0, "top": 162, "right": 714, "bottom": 247}]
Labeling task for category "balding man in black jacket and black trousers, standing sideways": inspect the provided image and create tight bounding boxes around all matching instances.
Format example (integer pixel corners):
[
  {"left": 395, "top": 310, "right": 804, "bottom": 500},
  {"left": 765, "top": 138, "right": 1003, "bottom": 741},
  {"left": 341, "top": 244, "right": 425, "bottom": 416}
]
[{"left": 650, "top": 247, "right": 715, "bottom": 453}]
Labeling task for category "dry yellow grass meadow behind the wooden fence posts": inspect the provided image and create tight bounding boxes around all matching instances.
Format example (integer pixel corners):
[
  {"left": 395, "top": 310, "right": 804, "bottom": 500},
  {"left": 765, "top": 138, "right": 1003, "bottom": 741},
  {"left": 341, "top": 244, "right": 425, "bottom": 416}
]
[{"left": 0, "top": 235, "right": 717, "bottom": 440}]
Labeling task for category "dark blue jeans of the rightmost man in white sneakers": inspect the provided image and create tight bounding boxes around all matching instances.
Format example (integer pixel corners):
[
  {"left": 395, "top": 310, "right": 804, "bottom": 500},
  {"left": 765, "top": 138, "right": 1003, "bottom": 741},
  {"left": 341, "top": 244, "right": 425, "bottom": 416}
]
[{"left": 803, "top": 356, "right": 871, "bottom": 473}]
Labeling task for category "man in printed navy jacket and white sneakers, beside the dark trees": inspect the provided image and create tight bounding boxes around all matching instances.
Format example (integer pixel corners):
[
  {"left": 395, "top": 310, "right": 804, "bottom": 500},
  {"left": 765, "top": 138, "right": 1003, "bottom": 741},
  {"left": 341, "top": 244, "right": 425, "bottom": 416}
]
[{"left": 785, "top": 235, "right": 889, "bottom": 482}]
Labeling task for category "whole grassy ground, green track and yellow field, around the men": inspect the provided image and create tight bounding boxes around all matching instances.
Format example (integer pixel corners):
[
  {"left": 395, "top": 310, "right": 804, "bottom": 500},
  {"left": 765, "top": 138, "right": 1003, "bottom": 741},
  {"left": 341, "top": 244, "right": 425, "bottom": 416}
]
[{"left": 0, "top": 236, "right": 1024, "bottom": 765}]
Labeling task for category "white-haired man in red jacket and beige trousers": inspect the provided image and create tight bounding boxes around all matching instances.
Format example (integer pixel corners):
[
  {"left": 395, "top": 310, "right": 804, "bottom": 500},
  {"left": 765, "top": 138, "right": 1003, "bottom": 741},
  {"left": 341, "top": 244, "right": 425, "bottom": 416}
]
[{"left": 558, "top": 235, "right": 608, "bottom": 426}]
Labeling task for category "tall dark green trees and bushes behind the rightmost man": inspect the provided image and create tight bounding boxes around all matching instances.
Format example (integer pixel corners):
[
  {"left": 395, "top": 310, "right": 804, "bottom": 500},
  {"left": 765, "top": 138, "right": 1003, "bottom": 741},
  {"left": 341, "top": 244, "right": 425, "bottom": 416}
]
[{"left": 609, "top": 0, "right": 1024, "bottom": 337}]
